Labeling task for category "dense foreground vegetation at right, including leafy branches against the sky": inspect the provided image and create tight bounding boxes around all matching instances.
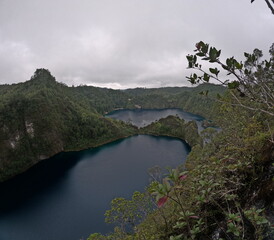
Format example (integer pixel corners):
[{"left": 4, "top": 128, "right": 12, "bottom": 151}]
[{"left": 88, "top": 45, "right": 274, "bottom": 240}]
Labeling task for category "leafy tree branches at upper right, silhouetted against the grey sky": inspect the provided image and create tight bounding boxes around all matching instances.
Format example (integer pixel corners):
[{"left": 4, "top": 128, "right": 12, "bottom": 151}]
[{"left": 187, "top": 41, "right": 274, "bottom": 116}]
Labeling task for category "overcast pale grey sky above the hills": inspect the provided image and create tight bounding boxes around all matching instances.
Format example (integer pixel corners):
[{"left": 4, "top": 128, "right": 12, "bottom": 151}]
[{"left": 0, "top": 0, "right": 274, "bottom": 88}]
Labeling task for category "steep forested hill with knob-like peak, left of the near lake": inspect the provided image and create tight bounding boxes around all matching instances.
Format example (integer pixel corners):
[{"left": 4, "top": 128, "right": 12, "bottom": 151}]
[{"left": 0, "top": 69, "right": 136, "bottom": 181}]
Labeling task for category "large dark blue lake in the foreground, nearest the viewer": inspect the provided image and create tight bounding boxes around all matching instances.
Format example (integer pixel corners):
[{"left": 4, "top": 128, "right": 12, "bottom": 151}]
[{"left": 0, "top": 135, "right": 190, "bottom": 240}]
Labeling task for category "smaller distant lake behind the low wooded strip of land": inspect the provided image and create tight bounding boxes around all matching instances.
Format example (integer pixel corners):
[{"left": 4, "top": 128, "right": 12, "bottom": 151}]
[{"left": 106, "top": 108, "right": 204, "bottom": 132}]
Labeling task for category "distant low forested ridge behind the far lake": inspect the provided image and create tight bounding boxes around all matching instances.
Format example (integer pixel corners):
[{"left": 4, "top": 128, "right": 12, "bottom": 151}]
[{"left": 75, "top": 84, "right": 225, "bottom": 118}]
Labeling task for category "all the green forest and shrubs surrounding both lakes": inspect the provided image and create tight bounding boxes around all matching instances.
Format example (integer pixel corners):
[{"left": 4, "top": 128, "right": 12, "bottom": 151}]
[{"left": 0, "top": 60, "right": 274, "bottom": 240}]
